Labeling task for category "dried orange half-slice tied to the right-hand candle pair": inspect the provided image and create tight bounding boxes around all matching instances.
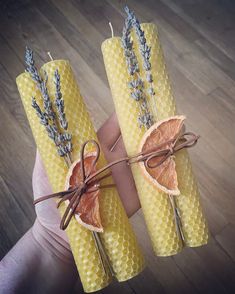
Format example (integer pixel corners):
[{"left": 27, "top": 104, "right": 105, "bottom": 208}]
[{"left": 139, "top": 115, "right": 185, "bottom": 195}]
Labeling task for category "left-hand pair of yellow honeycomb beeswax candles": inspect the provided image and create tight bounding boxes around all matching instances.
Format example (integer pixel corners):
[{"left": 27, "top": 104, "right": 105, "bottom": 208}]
[{"left": 16, "top": 60, "right": 144, "bottom": 292}]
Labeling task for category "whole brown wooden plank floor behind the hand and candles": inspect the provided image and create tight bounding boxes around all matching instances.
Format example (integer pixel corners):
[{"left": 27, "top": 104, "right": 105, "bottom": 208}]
[{"left": 0, "top": 0, "right": 235, "bottom": 294}]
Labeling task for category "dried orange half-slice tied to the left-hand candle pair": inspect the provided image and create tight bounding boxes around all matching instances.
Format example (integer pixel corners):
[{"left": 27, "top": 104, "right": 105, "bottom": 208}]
[{"left": 65, "top": 152, "right": 103, "bottom": 232}]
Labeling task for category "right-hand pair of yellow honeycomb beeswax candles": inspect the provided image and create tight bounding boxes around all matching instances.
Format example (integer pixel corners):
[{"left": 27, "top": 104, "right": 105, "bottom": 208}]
[{"left": 102, "top": 24, "right": 208, "bottom": 256}]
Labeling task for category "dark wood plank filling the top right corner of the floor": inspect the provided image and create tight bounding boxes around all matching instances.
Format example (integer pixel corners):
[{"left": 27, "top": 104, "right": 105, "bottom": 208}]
[{"left": 164, "top": 0, "right": 235, "bottom": 60}]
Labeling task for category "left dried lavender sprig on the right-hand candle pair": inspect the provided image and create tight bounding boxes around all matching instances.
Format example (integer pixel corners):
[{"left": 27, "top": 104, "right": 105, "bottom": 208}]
[{"left": 122, "top": 8, "right": 153, "bottom": 129}]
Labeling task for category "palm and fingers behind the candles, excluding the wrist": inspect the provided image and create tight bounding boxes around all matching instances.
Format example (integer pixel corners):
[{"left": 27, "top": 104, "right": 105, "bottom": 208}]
[{"left": 32, "top": 114, "right": 140, "bottom": 248}]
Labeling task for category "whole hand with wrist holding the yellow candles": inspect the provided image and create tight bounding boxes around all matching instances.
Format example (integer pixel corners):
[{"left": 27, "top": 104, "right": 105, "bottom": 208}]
[{"left": 0, "top": 114, "right": 140, "bottom": 293}]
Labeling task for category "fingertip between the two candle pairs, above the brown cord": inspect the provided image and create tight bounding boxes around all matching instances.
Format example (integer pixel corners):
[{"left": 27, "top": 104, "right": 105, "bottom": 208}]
[{"left": 97, "top": 112, "right": 121, "bottom": 149}]
